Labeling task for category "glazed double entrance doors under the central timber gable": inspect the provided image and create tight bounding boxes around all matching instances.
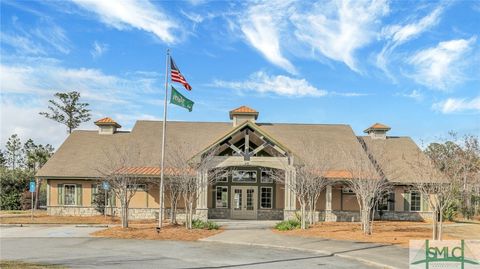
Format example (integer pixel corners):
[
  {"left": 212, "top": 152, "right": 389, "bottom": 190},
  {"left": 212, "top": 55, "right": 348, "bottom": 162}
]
[{"left": 231, "top": 186, "right": 258, "bottom": 219}]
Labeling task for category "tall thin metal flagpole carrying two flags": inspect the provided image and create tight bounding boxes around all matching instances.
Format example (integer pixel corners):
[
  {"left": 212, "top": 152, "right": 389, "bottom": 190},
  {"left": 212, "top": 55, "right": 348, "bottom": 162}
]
[{"left": 158, "top": 49, "right": 170, "bottom": 229}]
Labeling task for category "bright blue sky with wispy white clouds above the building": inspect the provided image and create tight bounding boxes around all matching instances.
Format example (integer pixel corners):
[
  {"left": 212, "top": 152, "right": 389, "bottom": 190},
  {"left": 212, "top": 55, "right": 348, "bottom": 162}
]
[{"left": 0, "top": 0, "right": 480, "bottom": 147}]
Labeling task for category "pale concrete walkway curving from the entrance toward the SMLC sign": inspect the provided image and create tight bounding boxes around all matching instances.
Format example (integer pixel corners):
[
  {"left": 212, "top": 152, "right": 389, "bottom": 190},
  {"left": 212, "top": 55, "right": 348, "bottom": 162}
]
[{"left": 201, "top": 227, "right": 408, "bottom": 268}]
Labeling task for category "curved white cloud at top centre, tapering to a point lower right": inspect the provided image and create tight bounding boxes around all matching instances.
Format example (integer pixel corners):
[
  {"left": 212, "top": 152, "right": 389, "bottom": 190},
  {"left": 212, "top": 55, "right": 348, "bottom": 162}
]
[{"left": 240, "top": 1, "right": 297, "bottom": 74}]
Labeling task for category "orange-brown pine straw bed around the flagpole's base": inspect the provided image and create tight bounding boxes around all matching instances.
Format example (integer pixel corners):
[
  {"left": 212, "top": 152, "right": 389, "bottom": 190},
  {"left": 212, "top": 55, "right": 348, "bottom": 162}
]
[{"left": 91, "top": 222, "right": 222, "bottom": 241}]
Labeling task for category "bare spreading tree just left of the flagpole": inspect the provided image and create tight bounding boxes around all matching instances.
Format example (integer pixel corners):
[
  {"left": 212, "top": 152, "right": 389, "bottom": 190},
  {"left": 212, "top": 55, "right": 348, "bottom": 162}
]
[{"left": 96, "top": 141, "right": 152, "bottom": 228}]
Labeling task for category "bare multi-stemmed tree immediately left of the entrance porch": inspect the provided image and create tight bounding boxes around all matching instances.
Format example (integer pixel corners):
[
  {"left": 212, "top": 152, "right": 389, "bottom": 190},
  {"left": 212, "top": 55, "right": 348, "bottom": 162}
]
[{"left": 167, "top": 143, "right": 224, "bottom": 229}]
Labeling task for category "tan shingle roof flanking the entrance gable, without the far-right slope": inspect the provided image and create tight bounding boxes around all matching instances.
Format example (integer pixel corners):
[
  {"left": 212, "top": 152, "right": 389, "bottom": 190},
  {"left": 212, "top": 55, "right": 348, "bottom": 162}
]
[{"left": 37, "top": 120, "right": 376, "bottom": 178}]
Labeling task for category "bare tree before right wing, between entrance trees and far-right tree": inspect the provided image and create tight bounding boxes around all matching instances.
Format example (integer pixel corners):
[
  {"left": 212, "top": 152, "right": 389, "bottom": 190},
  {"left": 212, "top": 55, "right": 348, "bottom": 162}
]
[{"left": 344, "top": 146, "right": 391, "bottom": 235}]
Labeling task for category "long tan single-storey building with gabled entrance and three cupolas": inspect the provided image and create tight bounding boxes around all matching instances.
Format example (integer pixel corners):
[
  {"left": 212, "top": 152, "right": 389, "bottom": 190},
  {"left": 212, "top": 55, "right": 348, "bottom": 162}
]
[{"left": 36, "top": 106, "right": 431, "bottom": 221}]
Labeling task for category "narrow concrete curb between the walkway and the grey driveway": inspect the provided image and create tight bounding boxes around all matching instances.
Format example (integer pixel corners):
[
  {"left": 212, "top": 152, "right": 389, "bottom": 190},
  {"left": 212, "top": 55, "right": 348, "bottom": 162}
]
[{"left": 202, "top": 238, "right": 400, "bottom": 269}]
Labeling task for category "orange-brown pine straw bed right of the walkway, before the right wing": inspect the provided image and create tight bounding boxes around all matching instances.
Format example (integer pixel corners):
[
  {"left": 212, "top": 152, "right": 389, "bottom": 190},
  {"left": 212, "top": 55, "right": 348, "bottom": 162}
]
[{"left": 275, "top": 221, "right": 480, "bottom": 247}]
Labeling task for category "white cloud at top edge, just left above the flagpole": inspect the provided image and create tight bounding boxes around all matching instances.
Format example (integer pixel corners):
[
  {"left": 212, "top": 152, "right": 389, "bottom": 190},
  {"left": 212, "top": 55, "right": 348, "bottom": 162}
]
[{"left": 72, "top": 0, "right": 178, "bottom": 44}]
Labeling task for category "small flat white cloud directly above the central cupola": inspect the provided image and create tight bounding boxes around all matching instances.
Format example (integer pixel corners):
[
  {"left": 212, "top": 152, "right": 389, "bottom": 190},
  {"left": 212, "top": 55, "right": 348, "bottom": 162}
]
[{"left": 211, "top": 71, "right": 327, "bottom": 97}]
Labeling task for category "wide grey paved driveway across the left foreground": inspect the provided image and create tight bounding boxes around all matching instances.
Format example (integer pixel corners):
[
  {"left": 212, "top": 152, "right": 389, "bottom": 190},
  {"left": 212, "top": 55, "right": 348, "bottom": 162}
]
[{"left": 0, "top": 226, "right": 371, "bottom": 269}]
